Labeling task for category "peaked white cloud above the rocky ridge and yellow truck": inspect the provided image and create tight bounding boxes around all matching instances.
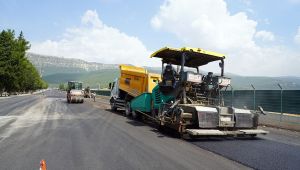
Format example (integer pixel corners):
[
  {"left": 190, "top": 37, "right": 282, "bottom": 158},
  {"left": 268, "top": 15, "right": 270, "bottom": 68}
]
[{"left": 30, "top": 10, "right": 157, "bottom": 66}]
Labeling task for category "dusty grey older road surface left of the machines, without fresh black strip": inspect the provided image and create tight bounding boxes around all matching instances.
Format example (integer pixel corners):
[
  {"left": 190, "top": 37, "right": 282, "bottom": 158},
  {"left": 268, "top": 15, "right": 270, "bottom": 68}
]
[{"left": 0, "top": 91, "right": 247, "bottom": 169}]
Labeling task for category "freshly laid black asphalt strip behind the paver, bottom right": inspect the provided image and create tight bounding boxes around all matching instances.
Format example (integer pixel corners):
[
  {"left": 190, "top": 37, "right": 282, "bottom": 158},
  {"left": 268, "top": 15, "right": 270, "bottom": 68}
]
[{"left": 192, "top": 135, "right": 300, "bottom": 170}]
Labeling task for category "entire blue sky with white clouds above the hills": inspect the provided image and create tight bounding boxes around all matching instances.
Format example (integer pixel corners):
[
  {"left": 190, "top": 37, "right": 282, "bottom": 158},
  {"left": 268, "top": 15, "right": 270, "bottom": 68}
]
[{"left": 0, "top": 0, "right": 300, "bottom": 77}]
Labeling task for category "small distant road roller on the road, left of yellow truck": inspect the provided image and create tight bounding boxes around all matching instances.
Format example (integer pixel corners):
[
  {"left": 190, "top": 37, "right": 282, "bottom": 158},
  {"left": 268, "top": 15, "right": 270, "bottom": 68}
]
[{"left": 67, "top": 81, "right": 84, "bottom": 103}]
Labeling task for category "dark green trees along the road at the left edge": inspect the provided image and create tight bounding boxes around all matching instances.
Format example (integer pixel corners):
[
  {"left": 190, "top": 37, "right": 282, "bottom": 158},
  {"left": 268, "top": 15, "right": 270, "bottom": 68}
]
[{"left": 0, "top": 29, "right": 48, "bottom": 95}]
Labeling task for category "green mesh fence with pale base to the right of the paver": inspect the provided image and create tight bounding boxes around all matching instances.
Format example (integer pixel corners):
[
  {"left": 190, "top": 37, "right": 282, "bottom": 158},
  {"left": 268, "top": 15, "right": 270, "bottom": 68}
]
[{"left": 221, "top": 85, "right": 300, "bottom": 131}]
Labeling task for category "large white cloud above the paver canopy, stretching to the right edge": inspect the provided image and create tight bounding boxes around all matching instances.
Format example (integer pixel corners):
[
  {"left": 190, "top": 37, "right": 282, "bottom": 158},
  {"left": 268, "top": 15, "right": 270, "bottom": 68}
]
[{"left": 151, "top": 0, "right": 300, "bottom": 76}]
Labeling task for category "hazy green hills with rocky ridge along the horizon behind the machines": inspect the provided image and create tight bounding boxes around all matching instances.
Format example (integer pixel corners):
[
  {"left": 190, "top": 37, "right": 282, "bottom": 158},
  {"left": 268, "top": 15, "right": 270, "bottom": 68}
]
[{"left": 27, "top": 53, "right": 300, "bottom": 90}]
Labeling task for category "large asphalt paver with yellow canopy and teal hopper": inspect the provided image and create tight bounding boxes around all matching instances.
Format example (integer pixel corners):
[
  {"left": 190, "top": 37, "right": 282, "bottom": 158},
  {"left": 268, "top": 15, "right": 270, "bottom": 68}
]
[{"left": 119, "top": 47, "right": 268, "bottom": 137}]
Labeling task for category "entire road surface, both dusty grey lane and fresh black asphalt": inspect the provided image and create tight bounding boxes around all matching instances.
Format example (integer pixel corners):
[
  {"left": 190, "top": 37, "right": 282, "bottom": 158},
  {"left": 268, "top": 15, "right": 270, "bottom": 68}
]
[{"left": 0, "top": 90, "right": 300, "bottom": 169}]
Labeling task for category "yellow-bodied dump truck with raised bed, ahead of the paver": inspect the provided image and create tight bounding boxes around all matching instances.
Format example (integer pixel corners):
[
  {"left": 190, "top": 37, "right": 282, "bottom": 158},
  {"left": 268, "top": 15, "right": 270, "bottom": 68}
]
[{"left": 109, "top": 65, "right": 161, "bottom": 117}]
